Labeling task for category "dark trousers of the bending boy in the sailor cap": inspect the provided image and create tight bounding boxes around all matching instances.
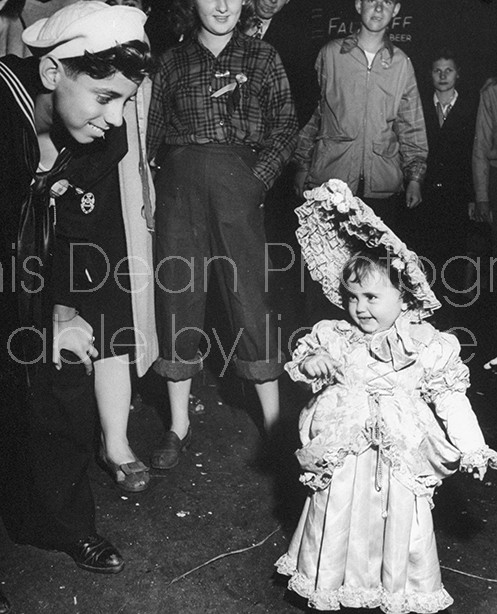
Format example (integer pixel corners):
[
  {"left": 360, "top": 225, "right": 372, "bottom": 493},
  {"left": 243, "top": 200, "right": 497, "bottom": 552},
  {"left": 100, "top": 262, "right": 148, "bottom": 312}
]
[{"left": 1, "top": 332, "right": 96, "bottom": 548}]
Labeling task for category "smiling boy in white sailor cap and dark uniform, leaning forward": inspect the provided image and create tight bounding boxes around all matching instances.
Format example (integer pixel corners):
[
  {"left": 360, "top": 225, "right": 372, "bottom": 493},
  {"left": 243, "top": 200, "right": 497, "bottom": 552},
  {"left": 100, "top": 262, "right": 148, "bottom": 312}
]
[{"left": 0, "top": 1, "right": 151, "bottom": 574}]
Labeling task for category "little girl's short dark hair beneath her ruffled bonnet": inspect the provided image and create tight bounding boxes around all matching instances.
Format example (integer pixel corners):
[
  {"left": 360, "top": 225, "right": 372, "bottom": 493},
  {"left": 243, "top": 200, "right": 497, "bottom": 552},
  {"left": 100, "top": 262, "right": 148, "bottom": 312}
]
[{"left": 340, "top": 248, "right": 417, "bottom": 308}]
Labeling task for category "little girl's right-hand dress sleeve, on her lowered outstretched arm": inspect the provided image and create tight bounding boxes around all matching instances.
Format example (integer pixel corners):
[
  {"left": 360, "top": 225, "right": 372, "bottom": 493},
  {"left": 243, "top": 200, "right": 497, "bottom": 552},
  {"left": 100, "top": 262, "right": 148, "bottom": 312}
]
[{"left": 423, "top": 333, "right": 495, "bottom": 470}]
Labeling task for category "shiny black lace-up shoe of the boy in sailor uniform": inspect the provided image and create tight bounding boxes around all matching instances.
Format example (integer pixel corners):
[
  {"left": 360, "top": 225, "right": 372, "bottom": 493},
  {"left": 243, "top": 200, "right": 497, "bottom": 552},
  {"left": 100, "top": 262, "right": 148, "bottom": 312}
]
[{"left": 61, "top": 535, "right": 124, "bottom": 574}]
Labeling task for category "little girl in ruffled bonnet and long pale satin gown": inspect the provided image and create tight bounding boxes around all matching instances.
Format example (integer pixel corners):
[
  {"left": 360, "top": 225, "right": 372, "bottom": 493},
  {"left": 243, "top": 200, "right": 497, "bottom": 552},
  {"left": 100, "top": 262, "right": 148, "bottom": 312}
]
[{"left": 276, "top": 180, "right": 496, "bottom": 614}]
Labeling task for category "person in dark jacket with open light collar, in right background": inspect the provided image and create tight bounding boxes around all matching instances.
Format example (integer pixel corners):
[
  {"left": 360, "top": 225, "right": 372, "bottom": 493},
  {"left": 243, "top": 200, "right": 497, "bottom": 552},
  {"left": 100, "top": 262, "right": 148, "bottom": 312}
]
[{"left": 417, "top": 49, "right": 476, "bottom": 299}]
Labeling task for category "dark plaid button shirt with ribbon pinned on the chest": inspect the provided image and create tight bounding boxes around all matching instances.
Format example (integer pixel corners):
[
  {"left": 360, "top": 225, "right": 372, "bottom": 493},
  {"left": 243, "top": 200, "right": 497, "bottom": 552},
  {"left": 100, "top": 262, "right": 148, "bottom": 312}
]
[{"left": 147, "top": 31, "right": 298, "bottom": 188}]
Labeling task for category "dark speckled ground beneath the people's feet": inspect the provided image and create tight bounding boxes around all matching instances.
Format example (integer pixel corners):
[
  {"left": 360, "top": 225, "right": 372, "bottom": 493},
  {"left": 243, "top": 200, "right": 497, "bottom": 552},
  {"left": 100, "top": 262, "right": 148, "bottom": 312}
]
[{"left": 0, "top": 256, "right": 497, "bottom": 614}]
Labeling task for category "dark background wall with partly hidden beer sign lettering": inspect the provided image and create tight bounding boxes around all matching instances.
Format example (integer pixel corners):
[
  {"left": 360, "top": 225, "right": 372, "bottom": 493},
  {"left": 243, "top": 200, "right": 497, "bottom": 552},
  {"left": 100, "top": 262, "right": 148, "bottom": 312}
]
[{"left": 278, "top": 0, "right": 497, "bottom": 98}]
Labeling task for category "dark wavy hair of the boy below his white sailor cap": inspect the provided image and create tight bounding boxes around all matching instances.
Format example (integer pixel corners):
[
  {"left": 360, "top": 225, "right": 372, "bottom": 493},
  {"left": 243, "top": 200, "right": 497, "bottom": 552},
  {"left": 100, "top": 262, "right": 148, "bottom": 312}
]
[{"left": 60, "top": 40, "right": 153, "bottom": 84}]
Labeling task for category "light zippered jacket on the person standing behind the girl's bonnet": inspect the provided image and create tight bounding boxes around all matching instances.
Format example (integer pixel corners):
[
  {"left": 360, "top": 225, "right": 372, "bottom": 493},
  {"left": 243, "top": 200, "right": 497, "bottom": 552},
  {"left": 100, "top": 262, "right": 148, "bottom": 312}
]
[{"left": 294, "top": 35, "right": 428, "bottom": 198}]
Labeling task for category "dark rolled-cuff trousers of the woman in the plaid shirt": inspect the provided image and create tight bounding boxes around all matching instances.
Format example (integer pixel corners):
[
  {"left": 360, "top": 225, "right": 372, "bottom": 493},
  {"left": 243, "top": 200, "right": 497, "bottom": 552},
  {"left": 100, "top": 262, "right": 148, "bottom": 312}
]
[{"left": 156, "top": 145, "right": 282, "bottom": 381}]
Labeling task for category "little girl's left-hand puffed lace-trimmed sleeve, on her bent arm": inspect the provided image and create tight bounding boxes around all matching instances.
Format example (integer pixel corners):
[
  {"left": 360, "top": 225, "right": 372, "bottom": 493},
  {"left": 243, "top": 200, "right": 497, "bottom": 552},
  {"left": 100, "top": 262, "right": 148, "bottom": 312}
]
[{"left": 285, "top": 320, "right": 344, "bottom": 392}]
